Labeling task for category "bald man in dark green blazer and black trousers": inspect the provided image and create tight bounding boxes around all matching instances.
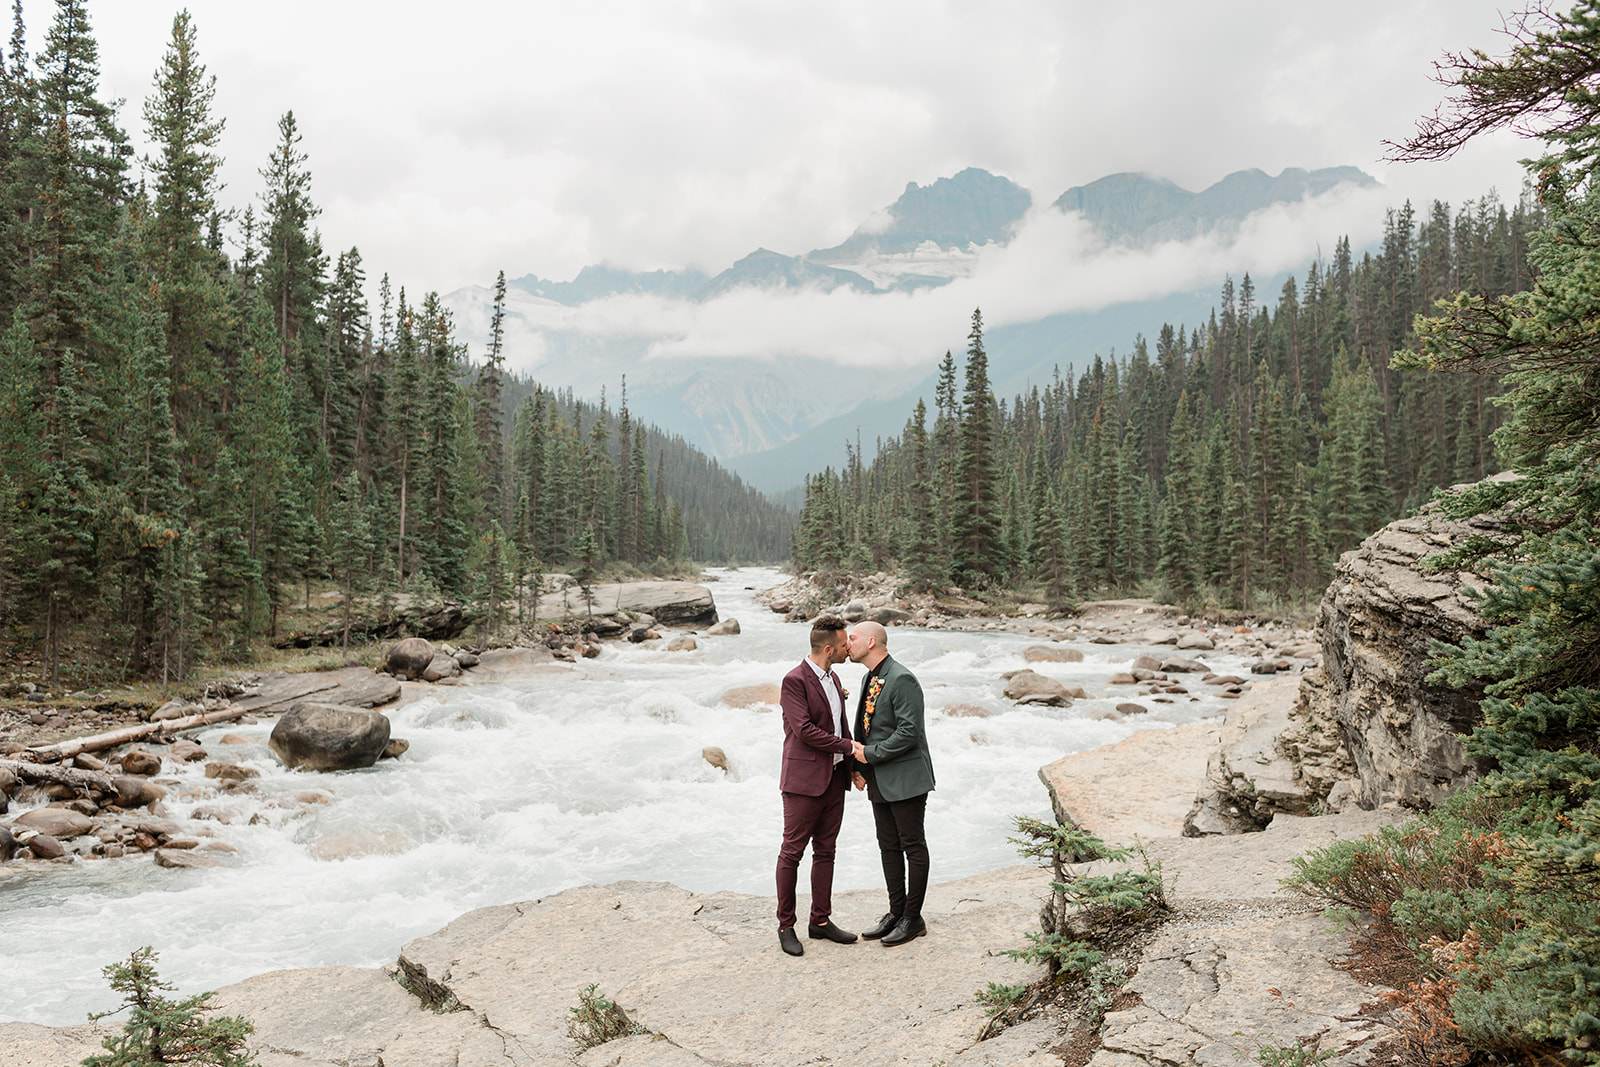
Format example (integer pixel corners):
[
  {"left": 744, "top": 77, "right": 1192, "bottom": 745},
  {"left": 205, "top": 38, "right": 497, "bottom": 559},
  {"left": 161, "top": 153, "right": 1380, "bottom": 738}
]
[{"left": 848, "top": 622, "right": 933, "bottom": 945}]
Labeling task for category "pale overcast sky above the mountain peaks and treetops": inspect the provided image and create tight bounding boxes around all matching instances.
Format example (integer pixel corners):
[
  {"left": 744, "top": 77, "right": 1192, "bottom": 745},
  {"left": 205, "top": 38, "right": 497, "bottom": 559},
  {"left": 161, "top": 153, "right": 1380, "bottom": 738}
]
[{"left": 56, "top": 0, "right": 1522, "bottom": 302}]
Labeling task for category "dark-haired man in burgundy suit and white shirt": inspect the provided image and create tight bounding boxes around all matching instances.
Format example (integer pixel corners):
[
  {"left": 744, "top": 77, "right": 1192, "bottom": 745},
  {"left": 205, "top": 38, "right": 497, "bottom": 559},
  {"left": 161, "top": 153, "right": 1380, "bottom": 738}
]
[{"left": 778, "top": 614, "right": 856, "bottom": 957}]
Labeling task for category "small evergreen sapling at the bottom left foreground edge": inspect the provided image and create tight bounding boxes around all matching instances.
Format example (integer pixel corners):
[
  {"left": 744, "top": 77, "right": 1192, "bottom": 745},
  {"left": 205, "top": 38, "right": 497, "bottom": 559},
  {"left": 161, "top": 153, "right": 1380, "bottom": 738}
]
[{"left": 83, "top": 945, "right": 256, "bottom": 1067}]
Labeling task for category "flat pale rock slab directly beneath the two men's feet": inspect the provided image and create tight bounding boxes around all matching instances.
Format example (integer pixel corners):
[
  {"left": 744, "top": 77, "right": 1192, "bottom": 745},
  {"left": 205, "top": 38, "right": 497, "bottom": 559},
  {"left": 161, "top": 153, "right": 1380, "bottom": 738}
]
[{"left": 0, "top": 870, "right": 1056, "bottom": 1067}]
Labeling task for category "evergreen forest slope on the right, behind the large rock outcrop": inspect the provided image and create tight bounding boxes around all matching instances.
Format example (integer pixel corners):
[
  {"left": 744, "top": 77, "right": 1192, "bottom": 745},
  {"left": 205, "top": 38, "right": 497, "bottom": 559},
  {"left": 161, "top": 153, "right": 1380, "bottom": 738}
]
[{"left": 794, "top": 194, "right": 1542, "bottom": 608}]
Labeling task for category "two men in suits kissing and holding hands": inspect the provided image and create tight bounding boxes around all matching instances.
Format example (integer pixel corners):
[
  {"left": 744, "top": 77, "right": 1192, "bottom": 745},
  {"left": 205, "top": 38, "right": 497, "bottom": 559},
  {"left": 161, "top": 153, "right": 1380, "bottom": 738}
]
[{"left": 778, "top": 614, "right": 933, "bottom": 957}]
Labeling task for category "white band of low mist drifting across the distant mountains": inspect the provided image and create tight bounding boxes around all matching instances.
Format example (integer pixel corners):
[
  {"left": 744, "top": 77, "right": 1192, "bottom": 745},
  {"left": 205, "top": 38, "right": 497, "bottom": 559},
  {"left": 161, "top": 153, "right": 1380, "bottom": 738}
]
[{"left": 486, "top": 186, "right": 1395, "bottom": 379}]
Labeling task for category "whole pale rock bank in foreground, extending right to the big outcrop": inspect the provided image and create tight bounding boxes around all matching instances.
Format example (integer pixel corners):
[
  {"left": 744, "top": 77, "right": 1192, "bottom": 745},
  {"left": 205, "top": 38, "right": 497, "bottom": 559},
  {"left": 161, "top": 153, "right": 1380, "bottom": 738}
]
[{"left": 0, "top": 668, "right": 1400, "bottom": 1067}]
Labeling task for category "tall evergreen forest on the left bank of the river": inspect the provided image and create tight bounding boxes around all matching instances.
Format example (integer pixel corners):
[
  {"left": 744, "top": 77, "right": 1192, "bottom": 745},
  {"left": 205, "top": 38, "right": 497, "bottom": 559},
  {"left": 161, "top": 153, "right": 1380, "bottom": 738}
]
[{"left": 0, "top": 0, "right": 790, "bottom": 680}]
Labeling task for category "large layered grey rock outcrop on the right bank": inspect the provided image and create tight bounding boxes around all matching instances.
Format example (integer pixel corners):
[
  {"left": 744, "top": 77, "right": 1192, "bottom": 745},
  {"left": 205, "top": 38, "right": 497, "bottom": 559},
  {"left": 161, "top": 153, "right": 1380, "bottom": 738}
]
[{"left": 1184, "top": 475, "right": 1510, "bottom": 835}]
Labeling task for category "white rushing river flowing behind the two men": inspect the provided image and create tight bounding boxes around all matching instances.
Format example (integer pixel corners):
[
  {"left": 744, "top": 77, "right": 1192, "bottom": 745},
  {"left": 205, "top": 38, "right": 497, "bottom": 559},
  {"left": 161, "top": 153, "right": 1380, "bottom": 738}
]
[{"left": 0, "top": 568, "right": 1242, "bottom": 1025}]
